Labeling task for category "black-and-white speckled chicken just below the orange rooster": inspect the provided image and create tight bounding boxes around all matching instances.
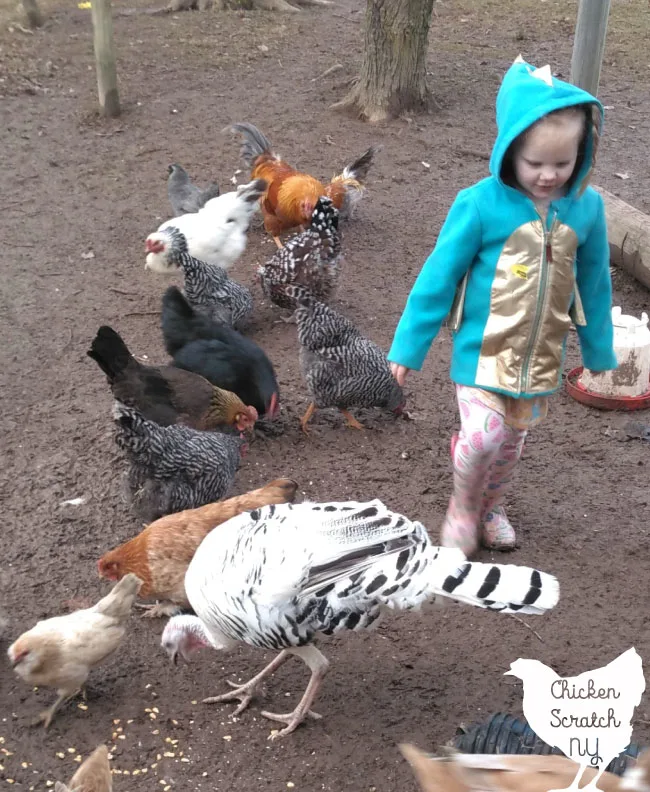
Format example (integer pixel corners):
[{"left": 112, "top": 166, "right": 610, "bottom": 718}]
[{"left": 257, "top": 197, "right": 341, "bottom": 318}]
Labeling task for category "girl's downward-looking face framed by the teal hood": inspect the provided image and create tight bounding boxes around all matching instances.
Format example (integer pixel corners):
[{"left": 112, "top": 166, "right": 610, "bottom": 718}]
[{"left": 513, "top": 115, "right": 584, "bottom": 201}]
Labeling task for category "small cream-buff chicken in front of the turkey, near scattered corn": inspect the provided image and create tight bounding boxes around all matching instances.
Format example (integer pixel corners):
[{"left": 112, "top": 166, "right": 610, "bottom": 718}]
[{"left": 7, "top": 575, "right": 142, "bottom": 729}]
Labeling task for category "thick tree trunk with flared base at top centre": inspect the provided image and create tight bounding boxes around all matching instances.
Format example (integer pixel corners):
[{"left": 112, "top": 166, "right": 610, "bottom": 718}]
[{"left": 333, "top": 0, "right": 434, "bottom": 121}]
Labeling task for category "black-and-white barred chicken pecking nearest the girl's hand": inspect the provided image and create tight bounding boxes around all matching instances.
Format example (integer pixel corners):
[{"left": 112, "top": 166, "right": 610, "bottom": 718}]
[{"left": 288, "top": 287, "right": 404, "bottom": 434}]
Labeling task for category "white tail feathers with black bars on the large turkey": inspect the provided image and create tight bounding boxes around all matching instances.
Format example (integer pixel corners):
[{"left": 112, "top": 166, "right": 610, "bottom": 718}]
[{"left": 432, "top": 547, "right": 560, "bottom": 615}]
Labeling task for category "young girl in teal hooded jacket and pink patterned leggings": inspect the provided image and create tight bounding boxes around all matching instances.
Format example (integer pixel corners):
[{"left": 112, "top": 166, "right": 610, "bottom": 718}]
[{"left": 388, "top": 57, "right": 616, "bottom": 555}]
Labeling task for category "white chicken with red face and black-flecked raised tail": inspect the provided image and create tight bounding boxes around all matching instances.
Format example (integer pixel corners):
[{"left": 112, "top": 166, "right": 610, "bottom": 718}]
[{"left": 144, "top": 179, "right": 266, "bottom": 274}]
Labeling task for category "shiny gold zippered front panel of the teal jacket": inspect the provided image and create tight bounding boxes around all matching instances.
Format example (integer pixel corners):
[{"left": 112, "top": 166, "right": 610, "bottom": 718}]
[{"left": 476, "top": 220, "right": 580, "bottom": 395}]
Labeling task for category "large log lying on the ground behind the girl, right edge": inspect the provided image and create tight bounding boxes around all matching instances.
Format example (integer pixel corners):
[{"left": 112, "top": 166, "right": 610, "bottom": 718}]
[{"left": 595, "top": 187, "right": 650, "bottom": 289}]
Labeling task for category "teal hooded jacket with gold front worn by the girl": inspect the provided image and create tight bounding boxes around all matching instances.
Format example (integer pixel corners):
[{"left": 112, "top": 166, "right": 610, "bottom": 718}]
[{"left": 388, "top": 59, "right": 617, "bottom": 398}]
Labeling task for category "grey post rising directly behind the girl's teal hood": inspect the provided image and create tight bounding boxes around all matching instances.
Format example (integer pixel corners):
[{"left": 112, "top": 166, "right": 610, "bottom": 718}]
[{"left": 571, "top": 0, "right": 611, "bottom": 96}]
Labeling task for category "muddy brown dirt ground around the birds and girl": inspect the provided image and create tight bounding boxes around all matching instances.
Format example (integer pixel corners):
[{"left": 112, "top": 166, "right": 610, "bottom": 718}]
[{"left": 0, "top": 0, "right": 650, "bottom": 792}]
